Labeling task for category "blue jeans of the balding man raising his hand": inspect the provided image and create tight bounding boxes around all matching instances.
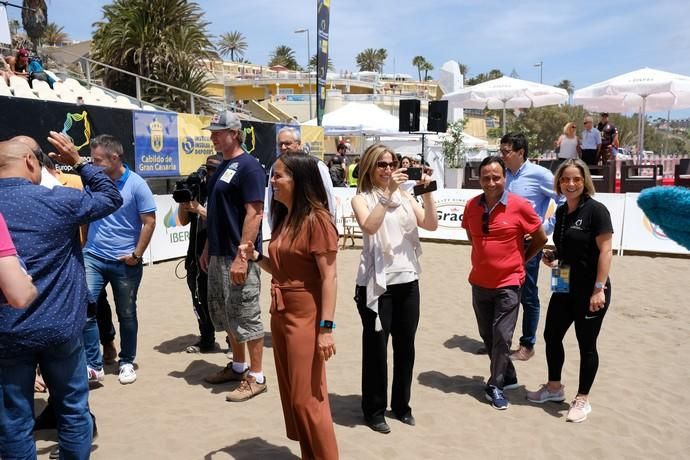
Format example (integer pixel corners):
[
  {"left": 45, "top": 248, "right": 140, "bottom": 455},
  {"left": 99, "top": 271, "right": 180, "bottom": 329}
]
[{"left": 0, "top": 336, "right": 93, "bottom": 459}]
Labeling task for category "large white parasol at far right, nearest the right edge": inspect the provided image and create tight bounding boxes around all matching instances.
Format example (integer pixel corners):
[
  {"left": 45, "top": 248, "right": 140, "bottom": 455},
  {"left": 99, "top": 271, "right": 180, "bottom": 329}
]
[{"left": 573, "top": 67, "right": 690, "bottom": 154}]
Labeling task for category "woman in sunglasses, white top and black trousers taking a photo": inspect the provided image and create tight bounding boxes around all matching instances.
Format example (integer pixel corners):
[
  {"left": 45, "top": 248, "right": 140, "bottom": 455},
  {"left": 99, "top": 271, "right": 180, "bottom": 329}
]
[{"left": 352, "top": 144, "right": 438, "bottom": 433}]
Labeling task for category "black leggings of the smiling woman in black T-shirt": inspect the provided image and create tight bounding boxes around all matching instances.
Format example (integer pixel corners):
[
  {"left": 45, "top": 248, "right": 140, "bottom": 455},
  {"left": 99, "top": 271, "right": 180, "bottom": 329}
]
[{"left": 544, "top": 284, "right": 611, "bottom": 395}]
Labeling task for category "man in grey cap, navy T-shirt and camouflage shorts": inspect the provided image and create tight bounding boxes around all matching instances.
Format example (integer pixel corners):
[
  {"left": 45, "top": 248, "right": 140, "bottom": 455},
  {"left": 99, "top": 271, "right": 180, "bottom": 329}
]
[{"left": 199, "top": 110, "right": 266, "bottom": 402}]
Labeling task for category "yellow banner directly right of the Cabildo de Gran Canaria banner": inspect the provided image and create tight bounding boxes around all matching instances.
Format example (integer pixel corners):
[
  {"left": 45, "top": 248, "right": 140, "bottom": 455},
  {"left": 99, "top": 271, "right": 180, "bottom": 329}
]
[{"left": 177, "top": 113, "right": 216, "bottom": 176}]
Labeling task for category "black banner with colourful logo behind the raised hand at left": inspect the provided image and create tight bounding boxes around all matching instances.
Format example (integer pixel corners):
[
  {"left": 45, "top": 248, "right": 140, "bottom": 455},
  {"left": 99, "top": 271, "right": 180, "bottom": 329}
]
[{"left": 0, "top": 97, "right": 134, "bottom": 172}]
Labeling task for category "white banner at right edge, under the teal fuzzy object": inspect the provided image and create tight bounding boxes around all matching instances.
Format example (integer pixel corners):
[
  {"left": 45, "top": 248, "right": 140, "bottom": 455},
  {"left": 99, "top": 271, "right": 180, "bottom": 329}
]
[{"left": 620, "top": 193, "right": 690, "bottom": 255}]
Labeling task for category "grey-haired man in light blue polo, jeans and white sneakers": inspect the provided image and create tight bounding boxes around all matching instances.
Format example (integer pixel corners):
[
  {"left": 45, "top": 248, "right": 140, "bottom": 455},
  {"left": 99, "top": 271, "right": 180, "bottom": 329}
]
[{"left": 84, "top": 134, "right": 156, "bottom": 385}]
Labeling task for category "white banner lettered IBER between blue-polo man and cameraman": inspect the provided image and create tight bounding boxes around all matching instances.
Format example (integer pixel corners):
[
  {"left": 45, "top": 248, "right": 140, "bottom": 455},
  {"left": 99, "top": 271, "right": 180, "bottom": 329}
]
[{"left": 149, "top": 195, "right": 189, "bottom": 262}]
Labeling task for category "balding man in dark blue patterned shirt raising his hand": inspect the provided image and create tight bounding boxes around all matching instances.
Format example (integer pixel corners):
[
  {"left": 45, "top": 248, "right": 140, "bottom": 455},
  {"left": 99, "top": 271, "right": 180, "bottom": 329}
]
[{"left": 0, "top": 132, "right": 122, "bottom": 459}]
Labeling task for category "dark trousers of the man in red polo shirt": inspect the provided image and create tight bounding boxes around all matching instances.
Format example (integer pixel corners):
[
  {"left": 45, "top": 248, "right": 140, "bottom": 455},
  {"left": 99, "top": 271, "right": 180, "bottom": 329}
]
[{"left": 472, "top": 286, "right": 520, "bottom": 389}]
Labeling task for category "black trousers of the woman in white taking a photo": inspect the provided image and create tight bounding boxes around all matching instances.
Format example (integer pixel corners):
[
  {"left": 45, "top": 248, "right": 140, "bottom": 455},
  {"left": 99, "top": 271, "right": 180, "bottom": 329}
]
[{"left": 355, "top": 281, "right": 419, "bottom": 422}]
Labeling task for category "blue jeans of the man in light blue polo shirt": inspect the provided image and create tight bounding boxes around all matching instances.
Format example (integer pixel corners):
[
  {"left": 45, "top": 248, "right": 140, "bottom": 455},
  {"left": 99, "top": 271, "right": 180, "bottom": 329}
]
[{"left": 84, "top": 253, "right": 144, "bottom": 369}]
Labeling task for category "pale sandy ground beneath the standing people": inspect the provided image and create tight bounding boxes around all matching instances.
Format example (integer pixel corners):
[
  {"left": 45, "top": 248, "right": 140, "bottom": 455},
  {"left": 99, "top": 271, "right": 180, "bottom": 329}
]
[{"left": 36, "top": 241, "right": 690, "bottom": 460}]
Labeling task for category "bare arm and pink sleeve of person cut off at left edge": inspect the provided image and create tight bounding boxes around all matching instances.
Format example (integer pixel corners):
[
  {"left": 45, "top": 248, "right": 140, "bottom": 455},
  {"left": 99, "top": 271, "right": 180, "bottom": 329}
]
[{"left": 0, "top": 214, "right": 38, "bottom": 308}]
